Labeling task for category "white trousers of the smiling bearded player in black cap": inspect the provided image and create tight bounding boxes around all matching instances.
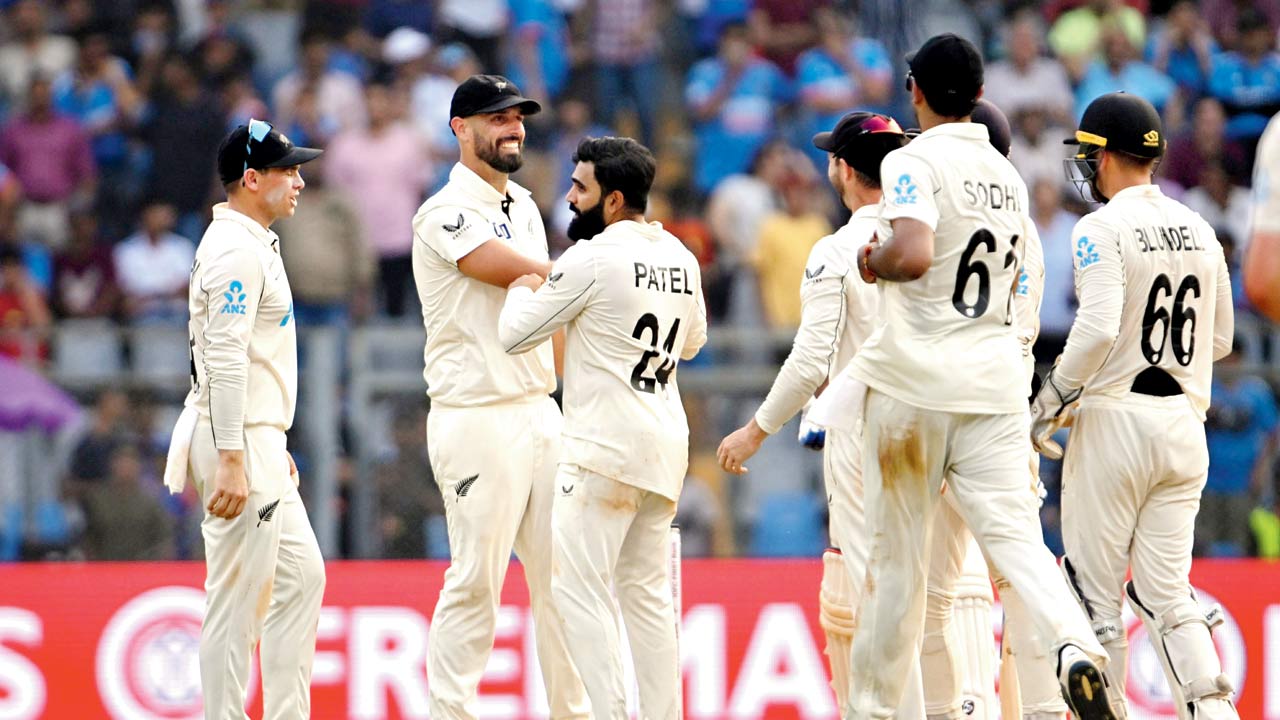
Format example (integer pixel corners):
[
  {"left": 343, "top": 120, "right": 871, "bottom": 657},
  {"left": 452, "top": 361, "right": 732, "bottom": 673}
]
[{"left": 426, "top": 396, "right": 589, "bottom": 720}]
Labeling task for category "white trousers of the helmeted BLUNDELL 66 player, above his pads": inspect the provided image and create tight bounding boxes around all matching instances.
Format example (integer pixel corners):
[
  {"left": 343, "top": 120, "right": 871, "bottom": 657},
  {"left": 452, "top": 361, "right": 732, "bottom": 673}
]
[{"left": 1062, "top": 393, "right": 1222, "bottom": 687}]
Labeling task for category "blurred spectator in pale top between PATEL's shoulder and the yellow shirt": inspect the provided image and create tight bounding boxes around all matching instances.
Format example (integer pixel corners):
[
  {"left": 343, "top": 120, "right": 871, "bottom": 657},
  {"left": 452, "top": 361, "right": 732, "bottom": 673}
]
[{"left": 703, "top": 140, "right": 792, "bottom": 319}]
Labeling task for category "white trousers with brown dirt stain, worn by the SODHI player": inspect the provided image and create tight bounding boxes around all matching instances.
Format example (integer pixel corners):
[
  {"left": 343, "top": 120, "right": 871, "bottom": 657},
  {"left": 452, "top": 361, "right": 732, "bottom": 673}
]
[{"left": 846, "top": 389, "right": 1106, "bottom": 720}]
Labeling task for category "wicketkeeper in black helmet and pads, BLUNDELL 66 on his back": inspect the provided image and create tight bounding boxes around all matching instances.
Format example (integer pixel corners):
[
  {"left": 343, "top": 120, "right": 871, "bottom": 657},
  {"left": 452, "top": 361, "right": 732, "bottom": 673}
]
[{"left": 1032, "top": 92, "right": 1236, "bottom": 720}]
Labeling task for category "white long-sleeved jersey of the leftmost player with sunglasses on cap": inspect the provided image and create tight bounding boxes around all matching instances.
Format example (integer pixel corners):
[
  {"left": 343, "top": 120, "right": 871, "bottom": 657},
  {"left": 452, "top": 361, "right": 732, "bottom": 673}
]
[{"left": 186, "top": 202, "right": 298, "bottom": 450}]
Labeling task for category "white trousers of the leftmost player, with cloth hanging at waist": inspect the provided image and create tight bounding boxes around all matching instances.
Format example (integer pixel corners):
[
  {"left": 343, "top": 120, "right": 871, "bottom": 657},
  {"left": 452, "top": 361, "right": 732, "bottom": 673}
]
[{"left": 191, "top": 419, "right": 325, "bottom": 720}]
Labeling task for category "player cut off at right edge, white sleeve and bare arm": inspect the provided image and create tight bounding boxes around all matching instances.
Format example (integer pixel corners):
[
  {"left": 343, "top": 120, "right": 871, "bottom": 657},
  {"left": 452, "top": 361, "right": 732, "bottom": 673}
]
[{"left": 1240, "top": 114, "right": 1280, "bottom": 323}]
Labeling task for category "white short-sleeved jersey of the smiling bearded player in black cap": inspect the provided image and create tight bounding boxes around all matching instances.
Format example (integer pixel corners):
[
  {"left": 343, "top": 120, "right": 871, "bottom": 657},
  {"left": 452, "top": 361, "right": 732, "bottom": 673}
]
[{"left": 413, "top": 163, "right": 556, "bottom": 407}]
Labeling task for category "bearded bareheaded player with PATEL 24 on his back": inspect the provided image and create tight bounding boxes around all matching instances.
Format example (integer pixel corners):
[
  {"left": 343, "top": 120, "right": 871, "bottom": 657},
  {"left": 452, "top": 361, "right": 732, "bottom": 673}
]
[{"left": 499, "top": 137, "right": 707, "bottom": 720}]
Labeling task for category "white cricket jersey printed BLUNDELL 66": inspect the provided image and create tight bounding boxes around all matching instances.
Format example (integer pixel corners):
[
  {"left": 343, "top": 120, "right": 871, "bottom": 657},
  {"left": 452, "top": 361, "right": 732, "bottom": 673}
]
[{"left": 1057, "top": 184, "right": 1235, "bottom": 419}]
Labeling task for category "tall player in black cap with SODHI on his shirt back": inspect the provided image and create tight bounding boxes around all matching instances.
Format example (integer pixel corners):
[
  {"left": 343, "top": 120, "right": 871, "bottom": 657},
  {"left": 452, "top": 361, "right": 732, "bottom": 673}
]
[{"left": 847, "top": 33, "right": 1111, "bottom": 720}]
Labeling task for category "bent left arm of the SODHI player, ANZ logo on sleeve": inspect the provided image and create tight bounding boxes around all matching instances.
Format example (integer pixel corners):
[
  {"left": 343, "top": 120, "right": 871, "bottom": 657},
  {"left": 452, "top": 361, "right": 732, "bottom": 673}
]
[{"left": 858, "top": 150, "right": 938, "bottom": 282}]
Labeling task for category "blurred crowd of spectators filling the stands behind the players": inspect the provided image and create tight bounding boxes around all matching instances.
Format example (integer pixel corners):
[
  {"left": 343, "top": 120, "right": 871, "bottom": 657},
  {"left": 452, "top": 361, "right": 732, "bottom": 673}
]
[{"left": 0, "top": 0, "right": 1280, "bottom": 559}]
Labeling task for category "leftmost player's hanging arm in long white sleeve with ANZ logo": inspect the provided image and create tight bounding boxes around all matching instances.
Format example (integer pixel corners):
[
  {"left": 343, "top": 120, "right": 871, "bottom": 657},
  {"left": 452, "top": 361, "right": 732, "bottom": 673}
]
[{"left": 200, "top": 249, "right": 265, "bottom": 519}]
